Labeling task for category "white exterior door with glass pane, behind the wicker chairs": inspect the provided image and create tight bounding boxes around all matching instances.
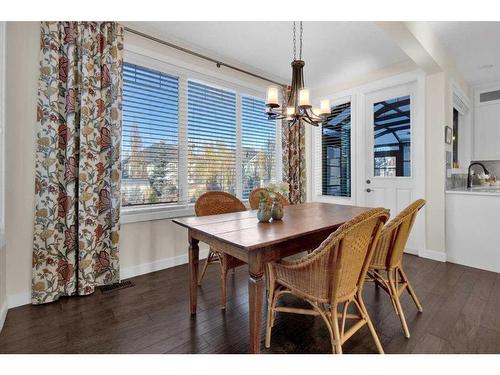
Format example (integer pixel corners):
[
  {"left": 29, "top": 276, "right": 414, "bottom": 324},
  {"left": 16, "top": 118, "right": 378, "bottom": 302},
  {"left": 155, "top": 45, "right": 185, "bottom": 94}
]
[{"left": 360, "top": 83, "right": 418, "bottom": 252}]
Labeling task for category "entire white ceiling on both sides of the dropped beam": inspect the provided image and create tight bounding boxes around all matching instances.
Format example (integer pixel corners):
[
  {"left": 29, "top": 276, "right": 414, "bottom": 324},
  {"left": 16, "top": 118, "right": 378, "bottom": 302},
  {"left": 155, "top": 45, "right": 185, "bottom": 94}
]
[{"left": 126, "top": 21, "right": 500, "bottom": 88}]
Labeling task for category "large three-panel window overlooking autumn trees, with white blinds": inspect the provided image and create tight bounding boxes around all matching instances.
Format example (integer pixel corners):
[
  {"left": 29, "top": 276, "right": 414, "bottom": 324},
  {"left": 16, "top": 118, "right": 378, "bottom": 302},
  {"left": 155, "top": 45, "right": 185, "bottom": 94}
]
[{"left": 122, "top": 59, "right": 281, "bottom": 214}]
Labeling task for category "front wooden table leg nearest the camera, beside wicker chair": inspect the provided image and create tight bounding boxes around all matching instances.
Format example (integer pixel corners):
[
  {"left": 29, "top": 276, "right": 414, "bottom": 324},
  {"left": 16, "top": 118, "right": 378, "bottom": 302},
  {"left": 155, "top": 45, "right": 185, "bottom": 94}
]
[{"left": 248, "top": 257, "right": 264, "bottom": 354}]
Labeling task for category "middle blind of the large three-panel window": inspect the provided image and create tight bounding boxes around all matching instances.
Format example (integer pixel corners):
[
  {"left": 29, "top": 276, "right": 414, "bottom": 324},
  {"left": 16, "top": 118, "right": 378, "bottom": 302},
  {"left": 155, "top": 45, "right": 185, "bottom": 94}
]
[{"left": 188, "top": 80, "right": 236, "bottom": 202}]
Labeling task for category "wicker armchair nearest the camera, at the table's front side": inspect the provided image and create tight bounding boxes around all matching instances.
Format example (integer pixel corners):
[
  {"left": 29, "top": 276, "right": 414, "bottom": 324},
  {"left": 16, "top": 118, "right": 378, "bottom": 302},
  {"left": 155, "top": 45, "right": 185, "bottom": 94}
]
[{"left": 266, "top": 208, "right": 389, "bottom": 354}]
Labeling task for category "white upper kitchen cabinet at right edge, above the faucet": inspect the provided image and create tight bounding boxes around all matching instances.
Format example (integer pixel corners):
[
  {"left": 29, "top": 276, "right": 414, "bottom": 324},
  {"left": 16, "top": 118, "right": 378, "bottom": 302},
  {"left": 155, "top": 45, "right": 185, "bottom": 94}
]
[{"left": 473, "top": 85, "right": 500, "bottom": 160}]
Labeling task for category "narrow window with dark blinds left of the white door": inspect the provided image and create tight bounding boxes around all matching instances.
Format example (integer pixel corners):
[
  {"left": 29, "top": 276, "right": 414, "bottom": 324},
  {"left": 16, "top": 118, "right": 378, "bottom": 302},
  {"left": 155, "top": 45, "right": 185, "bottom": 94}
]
[{"left": 321, "top": 103, "right": 351, "bottom": 197}]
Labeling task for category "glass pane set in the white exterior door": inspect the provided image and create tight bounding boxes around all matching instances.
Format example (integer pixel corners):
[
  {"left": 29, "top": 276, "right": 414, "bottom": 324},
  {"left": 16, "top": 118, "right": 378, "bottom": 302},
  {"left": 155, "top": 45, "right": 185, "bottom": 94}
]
[{"left": 373, "top": 95, "right": 411, "bottom": 177}]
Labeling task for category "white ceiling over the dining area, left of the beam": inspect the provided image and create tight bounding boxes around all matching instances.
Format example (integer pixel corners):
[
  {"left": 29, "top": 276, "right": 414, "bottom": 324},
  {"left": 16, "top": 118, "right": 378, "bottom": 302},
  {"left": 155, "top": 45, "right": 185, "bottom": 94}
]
[{"left": 127, "top": 22, "right": 408, "bottom": 88}]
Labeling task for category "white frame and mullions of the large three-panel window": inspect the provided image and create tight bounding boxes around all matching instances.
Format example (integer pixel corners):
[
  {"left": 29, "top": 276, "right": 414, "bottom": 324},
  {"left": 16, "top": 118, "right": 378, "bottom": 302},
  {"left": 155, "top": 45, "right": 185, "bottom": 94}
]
[{"left": 120, "top": 46, "right": 282, "bottom": 224}]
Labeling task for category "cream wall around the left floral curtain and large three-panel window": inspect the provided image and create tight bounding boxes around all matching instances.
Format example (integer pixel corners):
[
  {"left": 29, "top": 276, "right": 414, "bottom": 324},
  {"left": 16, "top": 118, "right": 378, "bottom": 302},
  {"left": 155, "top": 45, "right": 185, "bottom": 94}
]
[{"left": 0, "top": 22, "right": 267, "bottom": 307}]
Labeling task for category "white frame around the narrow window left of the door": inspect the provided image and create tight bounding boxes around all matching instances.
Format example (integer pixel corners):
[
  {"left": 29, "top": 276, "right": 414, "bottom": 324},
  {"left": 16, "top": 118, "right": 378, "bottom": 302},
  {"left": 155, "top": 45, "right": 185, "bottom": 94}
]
[{"left": 311, "top": 92, "right": 356, "bottom": 205}]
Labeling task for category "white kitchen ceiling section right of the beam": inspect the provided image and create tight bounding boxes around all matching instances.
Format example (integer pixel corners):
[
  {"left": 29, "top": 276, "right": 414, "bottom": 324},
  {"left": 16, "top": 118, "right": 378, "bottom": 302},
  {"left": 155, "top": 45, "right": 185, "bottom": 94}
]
[{"left": 429, "top": 22, "right": 500, "bottom": 85}]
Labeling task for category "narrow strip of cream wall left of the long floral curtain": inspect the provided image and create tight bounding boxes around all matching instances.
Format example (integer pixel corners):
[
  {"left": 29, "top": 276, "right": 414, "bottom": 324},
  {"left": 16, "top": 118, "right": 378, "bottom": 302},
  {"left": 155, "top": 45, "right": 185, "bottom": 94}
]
[{"left": 5, "top": 22, "right": 40, "bottom": 306}]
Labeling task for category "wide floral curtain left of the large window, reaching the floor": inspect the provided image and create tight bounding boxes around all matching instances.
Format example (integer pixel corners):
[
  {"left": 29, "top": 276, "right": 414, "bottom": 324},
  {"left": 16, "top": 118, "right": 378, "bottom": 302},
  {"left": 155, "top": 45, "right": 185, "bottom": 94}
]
[{"left": 32, "top": 22, "right": 123, "bottom": 304}]
